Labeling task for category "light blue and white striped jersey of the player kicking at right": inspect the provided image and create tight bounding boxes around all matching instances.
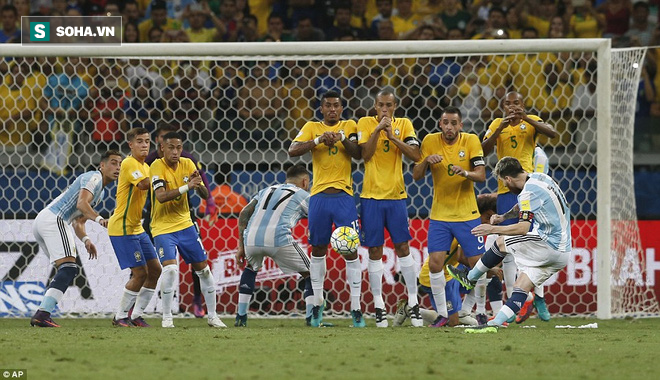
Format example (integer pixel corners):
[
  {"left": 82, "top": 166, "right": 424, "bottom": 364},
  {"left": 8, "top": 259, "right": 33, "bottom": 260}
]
[{"left": 518, "top": 173, "right": 571, "bottom": 252}]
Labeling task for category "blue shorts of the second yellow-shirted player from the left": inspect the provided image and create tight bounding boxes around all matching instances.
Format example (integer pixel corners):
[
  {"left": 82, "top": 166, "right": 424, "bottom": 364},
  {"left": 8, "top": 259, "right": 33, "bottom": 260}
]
[{"left": 154, "top": 226, "right": 206, "bottom": 264}]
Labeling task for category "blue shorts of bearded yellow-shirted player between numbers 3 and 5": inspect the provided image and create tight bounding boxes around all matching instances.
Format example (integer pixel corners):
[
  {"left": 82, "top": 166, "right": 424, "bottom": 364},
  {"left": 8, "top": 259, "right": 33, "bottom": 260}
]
[{"left": 428, "top": 218, "right": 485, "bottom": 257}]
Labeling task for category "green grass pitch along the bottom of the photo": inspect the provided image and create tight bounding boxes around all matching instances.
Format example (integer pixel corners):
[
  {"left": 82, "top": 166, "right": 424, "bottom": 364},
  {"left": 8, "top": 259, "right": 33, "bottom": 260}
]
[{"left": 0, "top": 318, "right": 660, "bottom": 380}]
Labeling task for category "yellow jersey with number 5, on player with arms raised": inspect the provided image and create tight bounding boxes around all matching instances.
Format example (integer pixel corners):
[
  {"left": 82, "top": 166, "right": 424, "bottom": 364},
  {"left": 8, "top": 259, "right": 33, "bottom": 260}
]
[{"left": 484, "top": 115, "right": 542, "bottom": 194}]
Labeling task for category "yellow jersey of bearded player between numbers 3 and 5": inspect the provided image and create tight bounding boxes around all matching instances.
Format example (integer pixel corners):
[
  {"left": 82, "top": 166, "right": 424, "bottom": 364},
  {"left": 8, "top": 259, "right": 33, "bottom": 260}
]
[{"left": 422, "top": 132, "right": 484, "bottom": 222}]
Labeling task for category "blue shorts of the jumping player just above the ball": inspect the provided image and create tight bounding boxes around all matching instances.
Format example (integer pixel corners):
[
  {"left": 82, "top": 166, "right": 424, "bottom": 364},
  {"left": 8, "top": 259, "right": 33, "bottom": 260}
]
[{"left": 307, "top": 191, "right": 360, "bottom": 246}]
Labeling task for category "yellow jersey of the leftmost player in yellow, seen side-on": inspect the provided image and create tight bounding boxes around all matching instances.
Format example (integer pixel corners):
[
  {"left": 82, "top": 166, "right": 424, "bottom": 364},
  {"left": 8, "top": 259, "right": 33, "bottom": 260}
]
[{"left": 108, "top": 156, "right": 149, "bottom": 236}]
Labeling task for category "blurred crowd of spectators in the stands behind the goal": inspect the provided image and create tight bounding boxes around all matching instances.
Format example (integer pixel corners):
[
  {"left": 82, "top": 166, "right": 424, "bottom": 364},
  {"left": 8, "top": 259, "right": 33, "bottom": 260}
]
[{"left": 0, "top": 0, "right": 660, "bottom": 157}]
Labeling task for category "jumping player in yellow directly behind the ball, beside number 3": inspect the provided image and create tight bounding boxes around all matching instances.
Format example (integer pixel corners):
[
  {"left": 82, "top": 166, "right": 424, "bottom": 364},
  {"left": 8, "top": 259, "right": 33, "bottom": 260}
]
[{"left": 289, "top": 91, "right": 364, "bottom": 327}]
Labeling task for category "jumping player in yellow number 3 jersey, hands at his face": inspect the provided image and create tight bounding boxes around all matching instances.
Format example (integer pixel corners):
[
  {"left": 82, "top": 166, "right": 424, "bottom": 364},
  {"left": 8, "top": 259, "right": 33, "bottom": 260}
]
[{"left": 357, "top": 90, "right": 423, "bottom": 327}]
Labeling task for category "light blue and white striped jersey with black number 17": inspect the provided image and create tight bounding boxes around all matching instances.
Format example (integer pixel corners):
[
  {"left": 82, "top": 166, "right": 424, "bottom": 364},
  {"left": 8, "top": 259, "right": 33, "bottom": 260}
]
[{"left": 244, "top": 184, "right": 309, "bottom": 247}]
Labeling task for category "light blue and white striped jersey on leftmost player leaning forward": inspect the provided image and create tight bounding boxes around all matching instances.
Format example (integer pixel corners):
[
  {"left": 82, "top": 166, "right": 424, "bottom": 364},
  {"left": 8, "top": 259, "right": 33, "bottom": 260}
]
[{"left": 46, "top": 170, "right": 105, "bottom": 223}]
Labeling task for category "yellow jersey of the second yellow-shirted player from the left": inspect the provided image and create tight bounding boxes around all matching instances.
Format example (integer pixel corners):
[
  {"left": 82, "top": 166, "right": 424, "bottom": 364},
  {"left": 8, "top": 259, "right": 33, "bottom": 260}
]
[{"left": 149, "top": 157, "right": 197, "bottom": 237}]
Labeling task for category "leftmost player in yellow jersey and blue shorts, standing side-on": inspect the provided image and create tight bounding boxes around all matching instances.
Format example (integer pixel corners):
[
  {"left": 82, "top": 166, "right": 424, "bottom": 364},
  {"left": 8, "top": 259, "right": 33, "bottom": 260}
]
[{"left": 108, "top": 128, "right": 161, "bottom": 327}]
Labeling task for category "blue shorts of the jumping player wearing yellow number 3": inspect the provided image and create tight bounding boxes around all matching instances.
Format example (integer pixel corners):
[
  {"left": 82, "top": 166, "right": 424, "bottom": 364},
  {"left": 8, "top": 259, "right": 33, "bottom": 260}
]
[{"left": 360, "top": 198, "right": 412, "bottom": 247}]
